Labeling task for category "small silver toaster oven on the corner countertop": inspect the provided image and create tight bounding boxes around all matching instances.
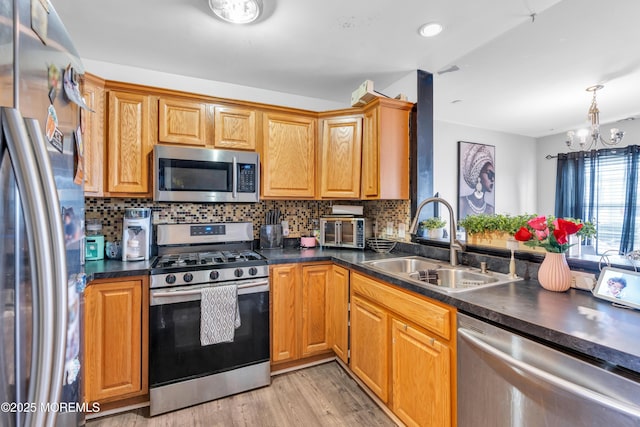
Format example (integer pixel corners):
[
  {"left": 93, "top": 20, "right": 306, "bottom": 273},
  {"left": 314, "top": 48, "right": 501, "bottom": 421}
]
[{"left": 320, "top": 217, "right": 373, "bottom": 249}]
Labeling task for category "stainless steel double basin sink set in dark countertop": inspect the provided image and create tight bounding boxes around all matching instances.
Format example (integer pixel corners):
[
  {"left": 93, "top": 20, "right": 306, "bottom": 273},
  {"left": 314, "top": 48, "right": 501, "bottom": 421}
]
[{"left": 362, "top": 256, "right": 520, "bottom": 293}]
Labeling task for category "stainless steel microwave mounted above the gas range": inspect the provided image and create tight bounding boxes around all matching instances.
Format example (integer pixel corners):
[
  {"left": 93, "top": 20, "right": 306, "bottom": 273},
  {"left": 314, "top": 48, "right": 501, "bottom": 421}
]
[{"left": 153, "top": 145, "right": 260, "bottom": 203}]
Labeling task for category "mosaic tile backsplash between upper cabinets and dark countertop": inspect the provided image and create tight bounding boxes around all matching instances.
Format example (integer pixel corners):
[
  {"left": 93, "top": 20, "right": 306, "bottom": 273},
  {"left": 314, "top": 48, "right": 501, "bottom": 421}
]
[{"left": 85, "top": 197, "right": 411, "bottom": 241}]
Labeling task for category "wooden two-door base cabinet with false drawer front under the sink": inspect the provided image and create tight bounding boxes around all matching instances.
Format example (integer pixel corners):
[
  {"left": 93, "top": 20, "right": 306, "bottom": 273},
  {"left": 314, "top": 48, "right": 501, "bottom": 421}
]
[{"left": 349, "top": 272, "right": 456, "bottom": 427}]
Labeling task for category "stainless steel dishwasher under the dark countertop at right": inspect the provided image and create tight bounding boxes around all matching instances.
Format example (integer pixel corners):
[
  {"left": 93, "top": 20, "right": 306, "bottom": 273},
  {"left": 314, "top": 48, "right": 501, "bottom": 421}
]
[{"left": 457, "top": 314, "right": 640, "bottom": 427}]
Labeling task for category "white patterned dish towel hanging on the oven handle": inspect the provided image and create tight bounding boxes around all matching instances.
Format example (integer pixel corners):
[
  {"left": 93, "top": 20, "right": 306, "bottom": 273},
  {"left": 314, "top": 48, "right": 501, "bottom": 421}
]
[{"left": 200, "top": 285, "right": 241, "bottom": 346}]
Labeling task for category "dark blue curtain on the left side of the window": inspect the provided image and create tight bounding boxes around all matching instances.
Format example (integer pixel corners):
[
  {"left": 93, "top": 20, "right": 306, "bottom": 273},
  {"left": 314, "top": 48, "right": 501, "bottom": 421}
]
[{"left": 555, "top": 151, "right": 588, "bottom": 219}]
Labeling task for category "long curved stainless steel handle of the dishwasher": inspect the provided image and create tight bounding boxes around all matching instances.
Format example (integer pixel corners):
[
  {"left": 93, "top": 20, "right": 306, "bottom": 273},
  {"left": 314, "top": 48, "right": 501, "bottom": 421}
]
[{"left": 458, "top": 328, "right": 640, "bottom": 417}]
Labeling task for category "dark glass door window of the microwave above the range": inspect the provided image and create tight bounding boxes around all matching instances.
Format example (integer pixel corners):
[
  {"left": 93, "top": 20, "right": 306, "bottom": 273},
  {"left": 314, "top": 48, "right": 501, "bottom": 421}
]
[{"left": 158, "top": 158, "right": 233, "bottom": 193}]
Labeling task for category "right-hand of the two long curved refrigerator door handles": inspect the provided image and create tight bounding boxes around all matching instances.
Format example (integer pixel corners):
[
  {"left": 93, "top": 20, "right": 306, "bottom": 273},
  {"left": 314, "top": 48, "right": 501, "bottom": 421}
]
[{"left": 25, "top": 118, "right": 68, "bottom": 426}]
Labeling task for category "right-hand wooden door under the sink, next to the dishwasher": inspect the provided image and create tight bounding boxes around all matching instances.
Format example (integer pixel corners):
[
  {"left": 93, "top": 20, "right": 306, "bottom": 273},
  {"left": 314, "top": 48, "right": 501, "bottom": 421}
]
[{"left": 391, "top": 319, "right": 450, "bottom": 427}]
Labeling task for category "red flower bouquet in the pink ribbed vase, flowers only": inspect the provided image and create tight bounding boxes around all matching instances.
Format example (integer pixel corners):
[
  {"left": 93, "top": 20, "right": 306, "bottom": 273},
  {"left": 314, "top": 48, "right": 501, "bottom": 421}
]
[{"left": 513, "top": 216, "right": 584, "bottom": 253}]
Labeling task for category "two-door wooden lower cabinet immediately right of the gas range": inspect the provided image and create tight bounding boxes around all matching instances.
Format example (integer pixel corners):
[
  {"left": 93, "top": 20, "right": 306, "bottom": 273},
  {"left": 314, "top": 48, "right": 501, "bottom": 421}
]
[{"left": 270, "top": 263, "right": 332, "bottom": 365}]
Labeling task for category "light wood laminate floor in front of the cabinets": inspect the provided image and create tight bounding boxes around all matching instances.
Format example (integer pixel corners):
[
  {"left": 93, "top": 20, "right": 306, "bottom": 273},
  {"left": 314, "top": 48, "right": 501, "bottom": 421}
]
[{"left": 87, "top": 362, "right": 396, "bottom": 427}]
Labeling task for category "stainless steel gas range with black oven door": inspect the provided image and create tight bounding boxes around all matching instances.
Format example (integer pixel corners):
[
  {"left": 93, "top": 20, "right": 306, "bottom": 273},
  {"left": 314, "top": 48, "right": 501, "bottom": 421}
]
[{"left": 149, "top": 222, "right": 271, "bottom": 416}]
